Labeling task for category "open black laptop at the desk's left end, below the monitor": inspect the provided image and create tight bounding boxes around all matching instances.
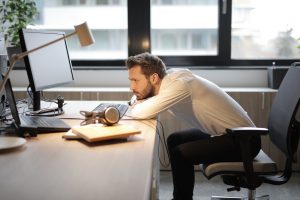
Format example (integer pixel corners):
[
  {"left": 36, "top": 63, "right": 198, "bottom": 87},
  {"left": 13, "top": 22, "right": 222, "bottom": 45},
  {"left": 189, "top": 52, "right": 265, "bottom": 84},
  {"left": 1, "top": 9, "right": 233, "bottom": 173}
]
[{"left": 5, "top": 79, "right": 71, "bottom": 133}]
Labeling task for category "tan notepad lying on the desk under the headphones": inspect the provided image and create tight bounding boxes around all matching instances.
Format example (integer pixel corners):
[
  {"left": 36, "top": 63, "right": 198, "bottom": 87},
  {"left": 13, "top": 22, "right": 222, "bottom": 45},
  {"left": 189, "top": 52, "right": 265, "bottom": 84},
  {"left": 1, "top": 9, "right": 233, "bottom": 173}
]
[{"left": 72, "top": 123, "right": 141, "bottom": 142}]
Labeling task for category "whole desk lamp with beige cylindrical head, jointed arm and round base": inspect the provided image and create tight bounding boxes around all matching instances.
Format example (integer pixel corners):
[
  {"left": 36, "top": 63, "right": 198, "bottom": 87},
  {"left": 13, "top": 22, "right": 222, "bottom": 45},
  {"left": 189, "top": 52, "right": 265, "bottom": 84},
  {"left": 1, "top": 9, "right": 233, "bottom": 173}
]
[{"left": 0, "top": 22, "right": 95, "bottom": 150}]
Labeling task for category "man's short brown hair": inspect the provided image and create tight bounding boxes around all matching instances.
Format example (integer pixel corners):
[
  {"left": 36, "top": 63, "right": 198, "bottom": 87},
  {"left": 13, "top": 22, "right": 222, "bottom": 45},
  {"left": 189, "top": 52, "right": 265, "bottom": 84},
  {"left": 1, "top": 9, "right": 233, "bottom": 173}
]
[{"left": 125, "top": 52, "right": 167, "bottom": 79}]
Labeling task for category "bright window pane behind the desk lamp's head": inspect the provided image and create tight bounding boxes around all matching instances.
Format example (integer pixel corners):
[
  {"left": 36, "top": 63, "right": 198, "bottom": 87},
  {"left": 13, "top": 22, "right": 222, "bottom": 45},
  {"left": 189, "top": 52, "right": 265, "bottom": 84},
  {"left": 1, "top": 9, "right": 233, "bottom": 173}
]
[{"left": 35, "top": 0, "right": 128, "bottom": 61}]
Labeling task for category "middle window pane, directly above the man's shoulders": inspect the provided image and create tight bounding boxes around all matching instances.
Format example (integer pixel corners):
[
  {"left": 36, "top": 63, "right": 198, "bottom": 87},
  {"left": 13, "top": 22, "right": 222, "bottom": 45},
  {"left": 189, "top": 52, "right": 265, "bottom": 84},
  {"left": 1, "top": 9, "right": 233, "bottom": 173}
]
[{"left": 151, "top": 0, "right": 219, "bottom": 56}]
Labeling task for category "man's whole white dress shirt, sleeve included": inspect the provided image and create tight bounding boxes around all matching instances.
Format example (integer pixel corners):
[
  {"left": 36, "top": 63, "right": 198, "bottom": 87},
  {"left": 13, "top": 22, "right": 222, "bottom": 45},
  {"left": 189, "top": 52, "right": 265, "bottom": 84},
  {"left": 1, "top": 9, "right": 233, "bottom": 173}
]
[{"left": 131, "top": 69, "right": 255, "bottom": 135}]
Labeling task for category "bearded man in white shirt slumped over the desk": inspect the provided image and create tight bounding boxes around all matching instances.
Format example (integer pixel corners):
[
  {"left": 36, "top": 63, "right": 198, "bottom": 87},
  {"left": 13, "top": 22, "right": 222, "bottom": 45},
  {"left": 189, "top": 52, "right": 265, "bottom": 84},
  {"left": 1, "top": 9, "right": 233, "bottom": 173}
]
[{"left": 126, "top": 53, "right": 261, "bottom": 200}]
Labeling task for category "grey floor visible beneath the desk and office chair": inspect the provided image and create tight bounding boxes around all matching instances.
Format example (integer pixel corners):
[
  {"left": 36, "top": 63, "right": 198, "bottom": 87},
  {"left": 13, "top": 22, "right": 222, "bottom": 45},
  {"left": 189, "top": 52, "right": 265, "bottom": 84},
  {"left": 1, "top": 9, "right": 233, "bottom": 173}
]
[{"left": 159, "top": 171, "right": 300, "bottom": 200}]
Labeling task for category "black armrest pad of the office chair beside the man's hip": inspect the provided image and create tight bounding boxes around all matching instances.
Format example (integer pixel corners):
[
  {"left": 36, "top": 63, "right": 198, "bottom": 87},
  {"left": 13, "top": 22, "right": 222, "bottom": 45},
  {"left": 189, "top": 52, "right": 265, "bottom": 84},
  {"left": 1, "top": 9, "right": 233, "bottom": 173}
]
[{"left": 226, "top": 127, "right": 269, "bottom": 137}]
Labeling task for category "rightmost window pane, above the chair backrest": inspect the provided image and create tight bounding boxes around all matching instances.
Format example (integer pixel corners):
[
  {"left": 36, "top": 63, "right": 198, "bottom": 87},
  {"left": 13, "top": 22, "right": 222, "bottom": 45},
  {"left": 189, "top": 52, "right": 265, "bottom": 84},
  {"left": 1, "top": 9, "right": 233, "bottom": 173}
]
[{"left": 231, "top": 0, "right": 300, "bottom": 59}]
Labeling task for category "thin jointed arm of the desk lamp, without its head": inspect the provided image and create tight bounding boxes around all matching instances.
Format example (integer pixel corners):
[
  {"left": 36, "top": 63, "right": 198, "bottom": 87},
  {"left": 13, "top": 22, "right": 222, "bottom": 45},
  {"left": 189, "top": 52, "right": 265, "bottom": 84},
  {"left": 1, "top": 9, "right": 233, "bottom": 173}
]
[{"left": 0, "top": 31, "right": 76, "bottom": 93}]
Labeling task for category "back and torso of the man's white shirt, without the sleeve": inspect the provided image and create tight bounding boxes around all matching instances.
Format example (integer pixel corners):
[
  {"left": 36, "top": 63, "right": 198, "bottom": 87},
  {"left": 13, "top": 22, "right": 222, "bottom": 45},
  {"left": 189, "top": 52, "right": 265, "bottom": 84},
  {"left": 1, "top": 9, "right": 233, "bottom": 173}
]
[{"left": 171, "top": 68, "right": 255, "bottom": 135}]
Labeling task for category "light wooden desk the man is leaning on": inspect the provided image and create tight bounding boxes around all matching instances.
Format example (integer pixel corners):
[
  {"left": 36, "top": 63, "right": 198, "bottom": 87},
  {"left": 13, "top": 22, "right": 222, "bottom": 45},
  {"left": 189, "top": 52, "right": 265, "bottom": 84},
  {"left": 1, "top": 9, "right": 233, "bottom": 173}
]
[{"left": 0, "top": 101, "right": 158, "bottom": 200}]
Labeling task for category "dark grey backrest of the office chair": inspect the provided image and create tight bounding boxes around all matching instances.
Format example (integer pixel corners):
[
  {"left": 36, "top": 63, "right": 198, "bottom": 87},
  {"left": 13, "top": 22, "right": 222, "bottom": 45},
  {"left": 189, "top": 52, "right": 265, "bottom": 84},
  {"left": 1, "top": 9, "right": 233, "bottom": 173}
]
[{"left": 268, "top": 66, "right": 300, "bottom": 159}]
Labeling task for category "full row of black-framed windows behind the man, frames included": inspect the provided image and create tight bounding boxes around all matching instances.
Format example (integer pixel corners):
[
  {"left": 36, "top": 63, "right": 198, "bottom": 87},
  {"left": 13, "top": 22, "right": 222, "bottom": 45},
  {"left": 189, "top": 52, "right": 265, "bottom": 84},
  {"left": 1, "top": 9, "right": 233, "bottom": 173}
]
[{"left": 31, "top": 0, "right": 300, "bottom": 68}]
